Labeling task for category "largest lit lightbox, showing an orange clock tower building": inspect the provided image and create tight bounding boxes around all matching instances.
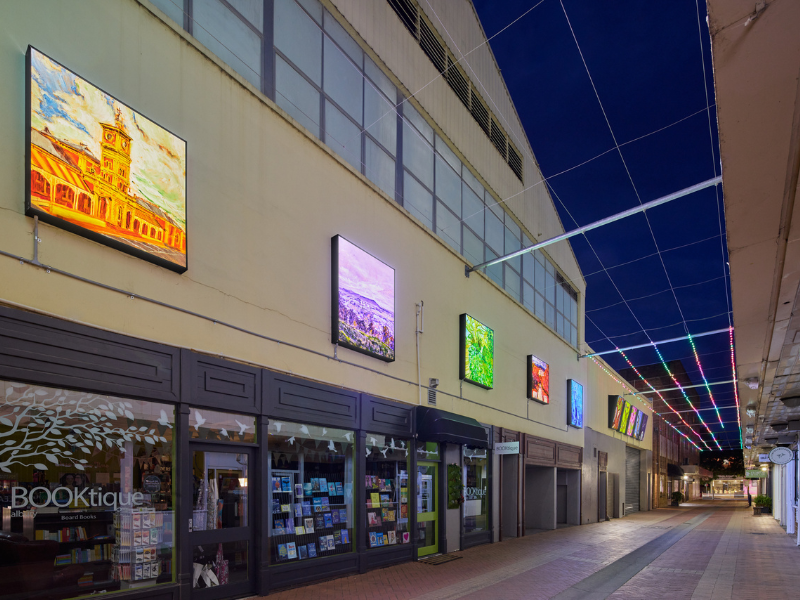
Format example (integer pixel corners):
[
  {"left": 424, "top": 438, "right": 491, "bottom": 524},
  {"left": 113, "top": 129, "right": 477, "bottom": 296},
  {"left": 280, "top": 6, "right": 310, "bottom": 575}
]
[{"left": 25, "top": 46, "right": 187, "bottom": 273}]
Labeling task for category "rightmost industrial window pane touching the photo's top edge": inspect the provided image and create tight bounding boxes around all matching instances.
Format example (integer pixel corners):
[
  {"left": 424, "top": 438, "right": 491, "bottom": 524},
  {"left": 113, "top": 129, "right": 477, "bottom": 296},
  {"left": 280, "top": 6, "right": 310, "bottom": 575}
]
[{"left": 275, "top": 0, "right": 322, "bottom": 85}]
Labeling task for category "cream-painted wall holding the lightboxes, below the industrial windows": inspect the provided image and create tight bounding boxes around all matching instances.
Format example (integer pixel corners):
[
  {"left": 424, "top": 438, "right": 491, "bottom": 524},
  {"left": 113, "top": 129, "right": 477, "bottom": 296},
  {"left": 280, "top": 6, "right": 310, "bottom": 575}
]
[{"left": 0, "top": 0, "right": 649, "bottom": 446}]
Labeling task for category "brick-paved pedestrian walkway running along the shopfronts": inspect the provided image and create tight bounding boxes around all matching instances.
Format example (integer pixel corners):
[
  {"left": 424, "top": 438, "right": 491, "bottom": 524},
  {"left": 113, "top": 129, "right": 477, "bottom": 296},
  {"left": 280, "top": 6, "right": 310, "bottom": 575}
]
[{"left": 262, "top": 500, "right": 800, "bottom": 600}]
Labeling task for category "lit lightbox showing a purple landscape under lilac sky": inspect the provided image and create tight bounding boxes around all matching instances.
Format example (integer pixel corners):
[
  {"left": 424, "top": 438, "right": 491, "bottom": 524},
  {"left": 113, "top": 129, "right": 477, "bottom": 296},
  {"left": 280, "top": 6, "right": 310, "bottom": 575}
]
[{"left": 331, "top": 235, "right": 394, "bottom": 362}]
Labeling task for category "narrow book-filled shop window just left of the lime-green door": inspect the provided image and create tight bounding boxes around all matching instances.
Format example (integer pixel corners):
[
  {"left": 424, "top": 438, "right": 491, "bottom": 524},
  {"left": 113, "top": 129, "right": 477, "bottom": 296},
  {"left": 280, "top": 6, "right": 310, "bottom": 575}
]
[{"left": 364, "top": 433, "right": 411, "bottom": 548}]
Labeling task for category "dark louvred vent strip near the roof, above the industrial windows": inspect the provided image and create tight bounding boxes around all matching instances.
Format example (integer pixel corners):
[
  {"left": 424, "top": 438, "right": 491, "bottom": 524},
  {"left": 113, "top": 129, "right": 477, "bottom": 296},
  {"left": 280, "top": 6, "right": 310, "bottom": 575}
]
[{"left": 388, "top": 0, "right": 524, "bottom": 183}]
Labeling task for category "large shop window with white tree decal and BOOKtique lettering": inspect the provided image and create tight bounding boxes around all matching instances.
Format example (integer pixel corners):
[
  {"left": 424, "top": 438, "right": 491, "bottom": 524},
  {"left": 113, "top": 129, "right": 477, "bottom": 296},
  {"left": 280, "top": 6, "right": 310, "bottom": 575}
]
[{"left": 0, "top": 381, "right": 175, "bottom": 599}]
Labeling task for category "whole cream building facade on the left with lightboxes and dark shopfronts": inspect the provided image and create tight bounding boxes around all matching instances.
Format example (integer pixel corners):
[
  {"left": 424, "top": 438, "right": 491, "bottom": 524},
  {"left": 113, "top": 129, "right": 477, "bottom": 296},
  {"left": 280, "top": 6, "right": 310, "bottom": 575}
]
[{"left": 0, "top": 0, "right": 653, "bottom": 598}]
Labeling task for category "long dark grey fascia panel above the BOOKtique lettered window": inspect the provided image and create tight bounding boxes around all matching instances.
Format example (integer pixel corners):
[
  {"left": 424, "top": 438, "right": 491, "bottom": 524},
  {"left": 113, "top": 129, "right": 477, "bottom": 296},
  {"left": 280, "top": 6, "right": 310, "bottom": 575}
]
[{"left": 0, "top": 307, "right": 180, "bottom": 402}]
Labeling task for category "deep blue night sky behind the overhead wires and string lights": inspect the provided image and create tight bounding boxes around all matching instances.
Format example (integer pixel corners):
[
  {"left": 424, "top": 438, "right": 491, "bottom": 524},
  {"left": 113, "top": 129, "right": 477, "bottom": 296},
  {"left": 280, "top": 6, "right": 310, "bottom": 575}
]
[{"left": 474, "top": 0, "right": 739, "bottom": 449}]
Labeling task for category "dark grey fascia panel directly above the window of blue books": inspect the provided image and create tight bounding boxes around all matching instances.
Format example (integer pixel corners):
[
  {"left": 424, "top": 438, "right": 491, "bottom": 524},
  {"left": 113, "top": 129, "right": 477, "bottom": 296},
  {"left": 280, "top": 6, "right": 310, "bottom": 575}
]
[{"left": 262, "top": 371, "right": 359, "bottom": 429}]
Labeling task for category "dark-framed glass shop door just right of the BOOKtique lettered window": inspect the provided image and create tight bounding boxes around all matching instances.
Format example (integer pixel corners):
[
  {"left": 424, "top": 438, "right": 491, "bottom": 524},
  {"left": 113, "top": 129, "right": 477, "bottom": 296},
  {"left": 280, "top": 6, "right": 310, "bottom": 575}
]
[{"left": 189, "top": 443, "right": 255, "bottom": 598}]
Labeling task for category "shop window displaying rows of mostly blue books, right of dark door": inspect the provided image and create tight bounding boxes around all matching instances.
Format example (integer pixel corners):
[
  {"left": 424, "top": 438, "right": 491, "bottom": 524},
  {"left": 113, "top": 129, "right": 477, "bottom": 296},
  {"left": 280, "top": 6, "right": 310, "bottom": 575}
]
[{"left": 267, "top": 421, "right": 355, "bottom": 565}]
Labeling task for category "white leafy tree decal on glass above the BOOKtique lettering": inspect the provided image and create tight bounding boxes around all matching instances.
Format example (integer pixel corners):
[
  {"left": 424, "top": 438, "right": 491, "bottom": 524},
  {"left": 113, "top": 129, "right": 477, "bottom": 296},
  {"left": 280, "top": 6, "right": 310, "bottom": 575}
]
[{"left": 0, "top": 381, "right": 172, "bottom": 473}]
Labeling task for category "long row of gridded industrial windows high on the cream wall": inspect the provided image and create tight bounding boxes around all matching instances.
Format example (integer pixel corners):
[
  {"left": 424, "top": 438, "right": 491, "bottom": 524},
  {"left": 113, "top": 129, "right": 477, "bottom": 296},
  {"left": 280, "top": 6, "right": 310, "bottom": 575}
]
[{"left": 148, "top": 0, "right": 578, "bottom": 346}]
